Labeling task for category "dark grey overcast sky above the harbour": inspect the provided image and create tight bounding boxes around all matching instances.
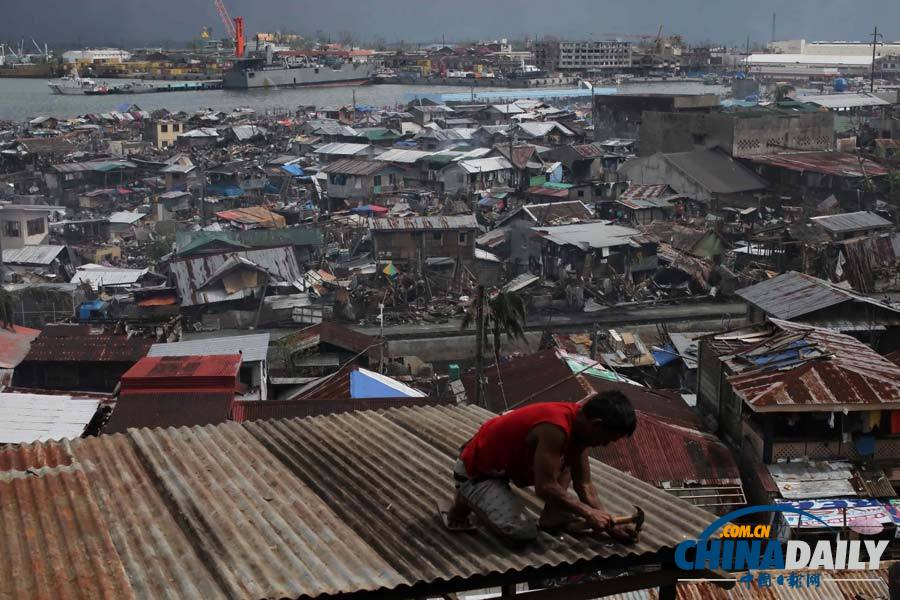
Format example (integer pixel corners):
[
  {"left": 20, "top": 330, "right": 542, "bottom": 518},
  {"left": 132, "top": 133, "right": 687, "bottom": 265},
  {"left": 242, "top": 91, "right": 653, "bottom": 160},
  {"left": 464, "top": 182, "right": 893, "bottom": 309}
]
[{"left": 7, "top": 0, "right": 900, "bottom": 45}]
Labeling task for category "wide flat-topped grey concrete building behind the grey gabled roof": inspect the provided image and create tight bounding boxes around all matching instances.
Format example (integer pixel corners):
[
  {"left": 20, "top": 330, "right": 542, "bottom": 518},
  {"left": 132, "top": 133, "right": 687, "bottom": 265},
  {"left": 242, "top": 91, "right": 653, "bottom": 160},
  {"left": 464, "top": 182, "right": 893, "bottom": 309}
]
[{"left": 640, "top": 109, "right": 834, "bottom": 158}]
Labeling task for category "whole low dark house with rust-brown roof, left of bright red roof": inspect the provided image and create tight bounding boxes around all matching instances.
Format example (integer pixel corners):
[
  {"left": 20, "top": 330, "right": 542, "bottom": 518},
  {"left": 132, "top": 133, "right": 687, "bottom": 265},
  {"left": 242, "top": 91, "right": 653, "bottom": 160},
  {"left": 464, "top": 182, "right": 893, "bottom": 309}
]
[{"left": 13, "top": 324, "right": 153, "bottom": 392}]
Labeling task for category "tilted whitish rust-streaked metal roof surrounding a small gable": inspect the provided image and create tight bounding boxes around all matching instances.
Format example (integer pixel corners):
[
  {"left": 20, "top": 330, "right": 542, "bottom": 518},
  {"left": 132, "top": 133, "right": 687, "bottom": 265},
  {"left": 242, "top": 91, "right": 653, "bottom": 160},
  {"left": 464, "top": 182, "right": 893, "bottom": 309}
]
[{"left": 169, "top": 246, "right": 303, "bottom": 306}]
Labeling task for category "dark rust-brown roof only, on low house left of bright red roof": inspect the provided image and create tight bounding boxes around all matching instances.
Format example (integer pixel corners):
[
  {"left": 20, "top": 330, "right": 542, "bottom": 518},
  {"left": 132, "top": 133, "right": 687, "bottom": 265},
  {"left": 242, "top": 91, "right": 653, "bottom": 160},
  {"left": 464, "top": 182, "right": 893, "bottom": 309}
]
[{"left": 25, "top": 324, "right": 153, "bottom": 363}]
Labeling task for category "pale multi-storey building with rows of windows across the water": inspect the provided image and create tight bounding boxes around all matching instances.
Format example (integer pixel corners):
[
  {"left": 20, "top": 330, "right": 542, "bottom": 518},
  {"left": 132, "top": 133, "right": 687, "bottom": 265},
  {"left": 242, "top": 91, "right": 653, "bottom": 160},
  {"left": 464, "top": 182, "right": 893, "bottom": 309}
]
[{"left": 534, "top": 41, "right": 631, "bottom": 73}]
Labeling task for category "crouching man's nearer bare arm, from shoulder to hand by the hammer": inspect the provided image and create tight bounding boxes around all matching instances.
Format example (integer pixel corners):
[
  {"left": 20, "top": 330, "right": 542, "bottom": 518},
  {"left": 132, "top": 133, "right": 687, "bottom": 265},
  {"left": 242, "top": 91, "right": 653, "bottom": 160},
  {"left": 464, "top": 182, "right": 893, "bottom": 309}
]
[{"left": 529, "top": 424, "right": 612, "bottom": 531}]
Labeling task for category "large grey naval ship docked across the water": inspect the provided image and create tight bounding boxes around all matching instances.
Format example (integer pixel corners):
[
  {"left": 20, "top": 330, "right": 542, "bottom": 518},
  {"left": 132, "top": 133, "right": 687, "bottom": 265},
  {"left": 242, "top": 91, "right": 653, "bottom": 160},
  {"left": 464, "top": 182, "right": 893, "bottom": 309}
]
[{"left": 222, "top": 48, "right": 375, "bottom": 90}]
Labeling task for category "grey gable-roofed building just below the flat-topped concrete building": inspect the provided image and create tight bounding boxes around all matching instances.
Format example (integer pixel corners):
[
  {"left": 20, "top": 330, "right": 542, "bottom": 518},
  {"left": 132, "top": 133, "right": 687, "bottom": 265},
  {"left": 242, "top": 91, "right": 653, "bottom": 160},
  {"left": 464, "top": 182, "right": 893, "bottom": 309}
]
[{"left": 619, "top": 149, "right": 769, "bottom": 209}]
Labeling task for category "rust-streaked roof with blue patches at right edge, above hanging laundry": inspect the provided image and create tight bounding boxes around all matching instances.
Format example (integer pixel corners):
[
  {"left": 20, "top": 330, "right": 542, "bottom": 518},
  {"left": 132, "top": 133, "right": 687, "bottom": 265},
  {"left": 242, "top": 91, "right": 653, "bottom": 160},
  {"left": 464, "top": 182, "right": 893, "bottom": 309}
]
[{"left": 727, "top": 319, "right": 900, "bottom": 412}]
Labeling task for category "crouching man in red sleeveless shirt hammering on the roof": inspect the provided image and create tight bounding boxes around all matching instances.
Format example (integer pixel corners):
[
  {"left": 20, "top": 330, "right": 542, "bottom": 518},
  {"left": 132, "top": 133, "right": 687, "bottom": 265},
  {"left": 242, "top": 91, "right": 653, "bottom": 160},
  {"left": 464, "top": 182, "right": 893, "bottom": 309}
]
[{"left": 447, "top": 391, "right": 637, "bottom": 543}]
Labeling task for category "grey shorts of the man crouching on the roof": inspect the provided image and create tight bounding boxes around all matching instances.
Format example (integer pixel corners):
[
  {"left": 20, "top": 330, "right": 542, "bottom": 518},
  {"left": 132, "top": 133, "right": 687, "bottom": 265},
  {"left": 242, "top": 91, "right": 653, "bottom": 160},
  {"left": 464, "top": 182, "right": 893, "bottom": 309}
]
[{"left": 453, "top": 459, "right": 537, "bottom": 543}]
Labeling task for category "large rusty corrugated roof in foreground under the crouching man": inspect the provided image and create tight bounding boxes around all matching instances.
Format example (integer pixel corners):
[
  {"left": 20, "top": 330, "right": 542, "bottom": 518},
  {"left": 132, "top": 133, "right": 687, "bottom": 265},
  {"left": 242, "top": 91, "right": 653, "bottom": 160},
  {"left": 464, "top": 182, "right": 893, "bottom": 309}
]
[{"left": 0, "top": 406, "right": 713, "bottom": 599}]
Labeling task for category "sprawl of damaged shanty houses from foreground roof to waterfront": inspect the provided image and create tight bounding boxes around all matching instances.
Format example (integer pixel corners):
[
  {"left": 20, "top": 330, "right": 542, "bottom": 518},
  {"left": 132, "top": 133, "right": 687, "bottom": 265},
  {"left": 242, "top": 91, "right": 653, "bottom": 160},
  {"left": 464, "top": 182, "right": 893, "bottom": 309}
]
[{"left": 0, "top": 63, "right": 900, "bottom": 599}]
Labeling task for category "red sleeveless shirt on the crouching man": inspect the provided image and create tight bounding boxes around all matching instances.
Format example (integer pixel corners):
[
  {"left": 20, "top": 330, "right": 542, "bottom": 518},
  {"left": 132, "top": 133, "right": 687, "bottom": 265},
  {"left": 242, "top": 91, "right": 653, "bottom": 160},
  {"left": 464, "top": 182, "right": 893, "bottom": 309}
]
[{"left": 460, "top": 402, "right": 579, "bottom": 487}]
